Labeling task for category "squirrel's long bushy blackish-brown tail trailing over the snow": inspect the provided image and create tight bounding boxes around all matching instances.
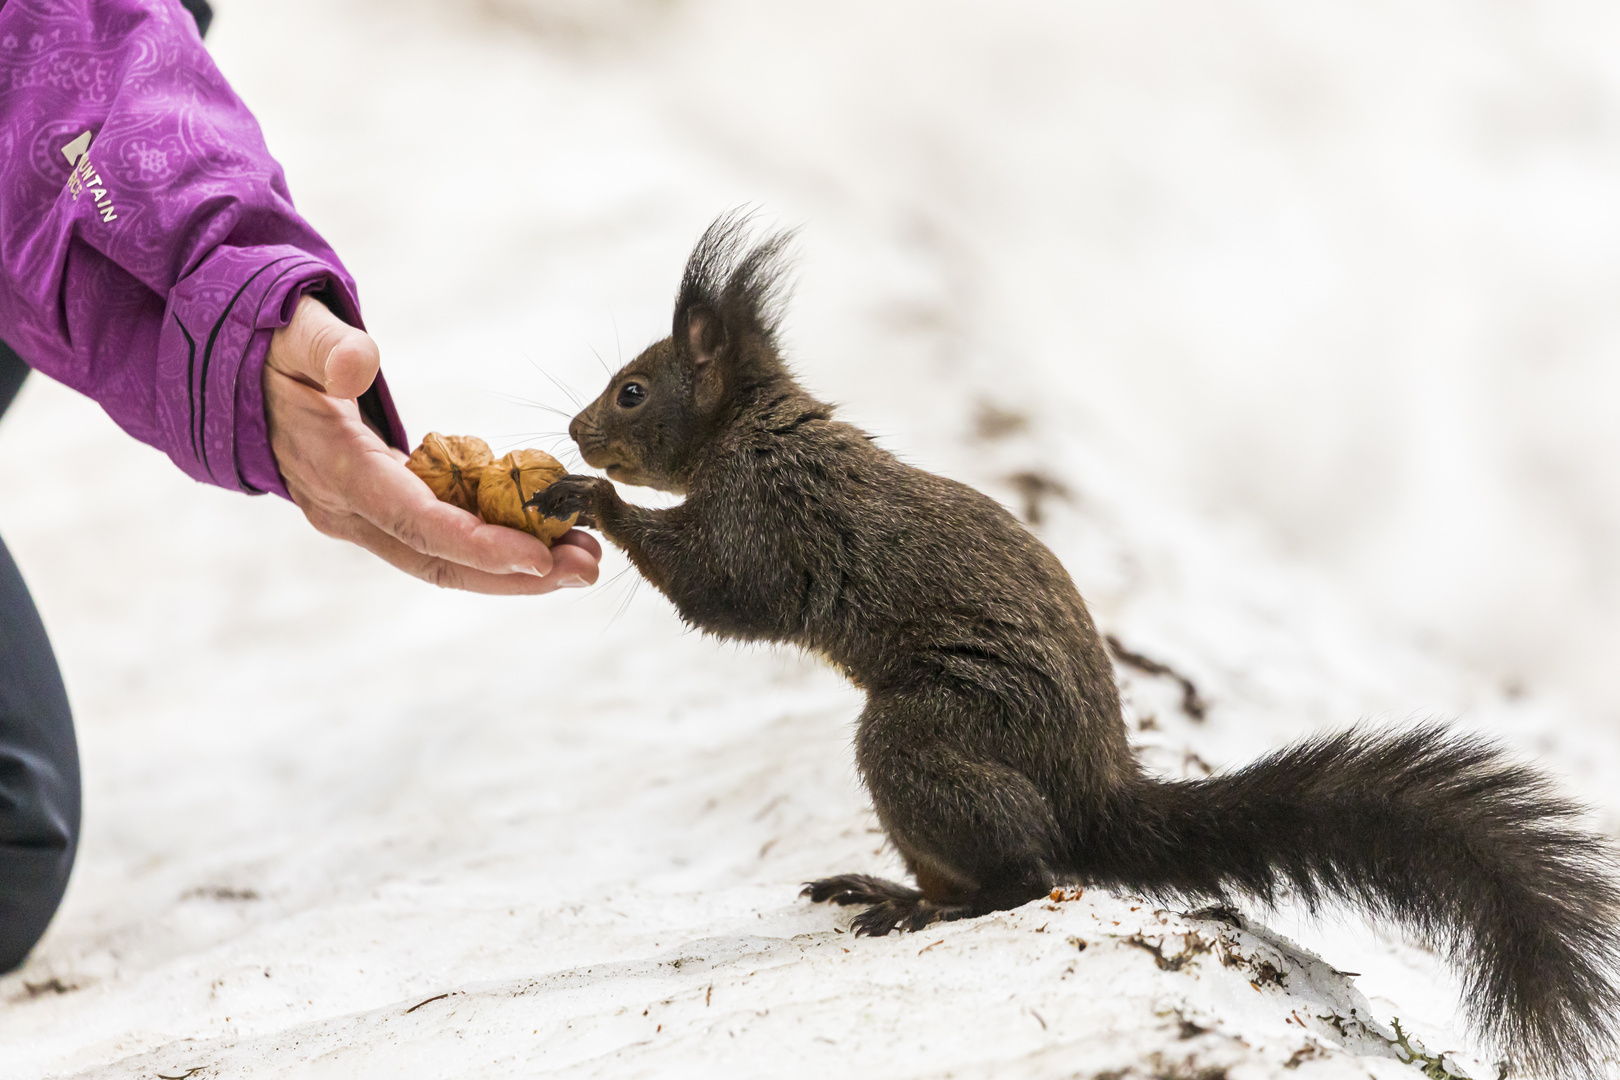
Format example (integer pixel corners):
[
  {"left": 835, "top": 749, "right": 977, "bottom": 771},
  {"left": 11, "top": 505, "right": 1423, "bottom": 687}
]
[{"left": 1081, "top": 727, "right": 1620, "bottom": 1075}]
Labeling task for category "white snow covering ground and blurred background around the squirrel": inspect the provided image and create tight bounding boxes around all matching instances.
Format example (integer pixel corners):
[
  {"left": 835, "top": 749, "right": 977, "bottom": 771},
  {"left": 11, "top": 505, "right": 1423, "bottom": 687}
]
[{"left": 0, "top": 0, "right": 1620, "bottom": 1080}]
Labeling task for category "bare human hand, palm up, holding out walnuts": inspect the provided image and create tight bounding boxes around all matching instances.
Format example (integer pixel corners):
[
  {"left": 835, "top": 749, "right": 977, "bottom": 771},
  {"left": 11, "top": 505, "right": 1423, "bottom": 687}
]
[{"left": 264, "top": 296, "right": 601, "bottom": 594}]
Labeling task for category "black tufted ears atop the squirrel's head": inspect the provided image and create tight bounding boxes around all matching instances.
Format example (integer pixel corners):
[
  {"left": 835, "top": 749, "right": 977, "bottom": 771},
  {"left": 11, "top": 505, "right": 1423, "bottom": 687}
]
[{"left": 674, "top": 209, "right": 792, "bottom": 363}]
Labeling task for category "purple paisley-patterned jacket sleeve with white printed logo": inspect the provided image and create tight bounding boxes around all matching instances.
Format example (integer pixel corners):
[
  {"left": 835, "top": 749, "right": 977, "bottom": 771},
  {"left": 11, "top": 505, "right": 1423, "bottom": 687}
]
[{"left": 0, "top": 0, "right": 410, "bottom": 495}]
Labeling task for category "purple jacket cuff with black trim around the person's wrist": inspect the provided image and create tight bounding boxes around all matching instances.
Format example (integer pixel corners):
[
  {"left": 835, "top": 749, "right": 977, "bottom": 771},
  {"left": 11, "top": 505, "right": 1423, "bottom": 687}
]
[{"left": 157, "top": 246, "right": 408, "bottom": 497}]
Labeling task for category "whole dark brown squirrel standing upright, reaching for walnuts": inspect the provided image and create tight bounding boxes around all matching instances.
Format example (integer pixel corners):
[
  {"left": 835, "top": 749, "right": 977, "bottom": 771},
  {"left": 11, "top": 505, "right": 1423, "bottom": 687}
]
[{"left": 530, "top": 214, "right": 1620, "bottom": 1075}]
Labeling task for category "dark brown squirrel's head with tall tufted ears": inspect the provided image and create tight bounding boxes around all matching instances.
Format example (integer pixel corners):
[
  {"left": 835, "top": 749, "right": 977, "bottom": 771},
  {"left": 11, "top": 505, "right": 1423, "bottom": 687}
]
[{"left": 569, "top": 212, "right": 791, "bottom": 494}]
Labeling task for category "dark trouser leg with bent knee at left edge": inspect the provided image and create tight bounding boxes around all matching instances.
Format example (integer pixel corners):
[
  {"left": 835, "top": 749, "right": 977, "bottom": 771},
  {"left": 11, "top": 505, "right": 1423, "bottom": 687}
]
[{"left": 0, "top": 542, "right": 79, "bottom": 972}]
